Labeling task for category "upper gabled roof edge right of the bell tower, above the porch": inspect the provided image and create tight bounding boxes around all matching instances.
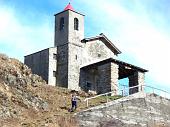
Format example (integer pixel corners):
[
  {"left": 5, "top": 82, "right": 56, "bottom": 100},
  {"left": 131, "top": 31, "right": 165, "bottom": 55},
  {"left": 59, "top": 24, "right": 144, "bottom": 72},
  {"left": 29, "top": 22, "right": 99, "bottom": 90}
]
[{"left": 81, "top": 33, "right": 122, "bottom": 55}]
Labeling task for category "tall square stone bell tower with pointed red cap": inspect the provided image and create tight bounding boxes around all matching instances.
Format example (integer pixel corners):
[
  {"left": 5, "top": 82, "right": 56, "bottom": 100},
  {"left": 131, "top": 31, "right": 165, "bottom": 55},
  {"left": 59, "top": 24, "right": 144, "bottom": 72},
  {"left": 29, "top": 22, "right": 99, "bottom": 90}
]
[{"left": 54, "top": 3, "right": 84, "bottom": 90}]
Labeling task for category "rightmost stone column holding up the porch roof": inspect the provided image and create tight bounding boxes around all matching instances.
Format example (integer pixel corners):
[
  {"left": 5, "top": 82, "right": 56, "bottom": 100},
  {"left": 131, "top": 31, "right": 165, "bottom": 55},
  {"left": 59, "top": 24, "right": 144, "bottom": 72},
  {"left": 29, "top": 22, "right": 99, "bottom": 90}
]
[{"left": 128, "top": 72, "right": 145, "bottom": 94}]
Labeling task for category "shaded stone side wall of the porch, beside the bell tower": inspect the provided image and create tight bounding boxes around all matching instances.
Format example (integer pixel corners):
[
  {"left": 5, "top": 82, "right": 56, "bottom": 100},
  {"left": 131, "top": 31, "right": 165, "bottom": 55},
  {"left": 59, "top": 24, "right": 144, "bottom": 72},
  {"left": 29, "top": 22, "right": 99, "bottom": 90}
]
[{"left": 80, "top": 63, "right": 111, "bottom": 94}]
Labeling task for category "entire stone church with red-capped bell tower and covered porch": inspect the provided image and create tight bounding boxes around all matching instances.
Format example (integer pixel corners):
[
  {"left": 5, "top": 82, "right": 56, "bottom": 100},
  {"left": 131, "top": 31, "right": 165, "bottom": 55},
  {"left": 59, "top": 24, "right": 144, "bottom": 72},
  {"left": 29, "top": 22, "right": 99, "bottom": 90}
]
[{"left": 24, "top": 3, "right": 147, "bottom": 94}]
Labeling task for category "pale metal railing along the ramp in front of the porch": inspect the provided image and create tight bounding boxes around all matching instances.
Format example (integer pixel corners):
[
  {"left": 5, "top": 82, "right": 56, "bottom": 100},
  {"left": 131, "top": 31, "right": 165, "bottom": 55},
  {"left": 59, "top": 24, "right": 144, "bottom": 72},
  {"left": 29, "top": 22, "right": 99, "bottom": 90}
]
[{"left": 84, "top": 85, "right": 170, "bottom": 107}]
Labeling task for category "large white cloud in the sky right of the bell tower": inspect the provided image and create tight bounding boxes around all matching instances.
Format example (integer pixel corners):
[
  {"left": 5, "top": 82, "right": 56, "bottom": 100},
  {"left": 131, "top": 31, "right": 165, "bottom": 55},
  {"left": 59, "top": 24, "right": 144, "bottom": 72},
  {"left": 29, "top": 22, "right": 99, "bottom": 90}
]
[{"left": 79, "top": 0, "right": 170, "bottom": 90}]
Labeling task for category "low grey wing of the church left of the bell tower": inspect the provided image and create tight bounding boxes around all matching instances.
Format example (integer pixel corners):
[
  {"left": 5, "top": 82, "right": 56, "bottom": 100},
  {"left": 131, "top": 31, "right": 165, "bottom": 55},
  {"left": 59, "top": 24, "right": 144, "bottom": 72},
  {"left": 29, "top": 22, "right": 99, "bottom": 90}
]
[{"left": 24, "top": 47, "right": 57, "bottom": 85}]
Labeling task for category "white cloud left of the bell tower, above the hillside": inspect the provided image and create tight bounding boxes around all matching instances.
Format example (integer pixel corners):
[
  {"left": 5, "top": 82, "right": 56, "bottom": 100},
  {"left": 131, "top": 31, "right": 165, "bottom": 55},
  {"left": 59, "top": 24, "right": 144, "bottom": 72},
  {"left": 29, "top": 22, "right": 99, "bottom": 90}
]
[{"left": 0, "top": 8, "right": 53, "bottom": 60}]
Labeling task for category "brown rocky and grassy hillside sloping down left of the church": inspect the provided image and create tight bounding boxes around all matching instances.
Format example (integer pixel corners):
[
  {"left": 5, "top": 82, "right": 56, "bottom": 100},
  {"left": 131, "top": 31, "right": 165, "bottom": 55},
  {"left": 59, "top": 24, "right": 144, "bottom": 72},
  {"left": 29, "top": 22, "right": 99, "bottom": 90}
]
[{"left": 0, "top": 54, "right": 83, "bottom": 127}]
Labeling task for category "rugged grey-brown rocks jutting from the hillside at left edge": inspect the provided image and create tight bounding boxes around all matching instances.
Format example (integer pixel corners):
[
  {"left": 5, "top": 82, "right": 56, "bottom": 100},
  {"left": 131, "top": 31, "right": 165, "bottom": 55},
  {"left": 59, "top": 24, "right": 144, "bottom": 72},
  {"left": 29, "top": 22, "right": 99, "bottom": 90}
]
[{"left": 0, "top": 54, "right": 48, "bottom": 119}]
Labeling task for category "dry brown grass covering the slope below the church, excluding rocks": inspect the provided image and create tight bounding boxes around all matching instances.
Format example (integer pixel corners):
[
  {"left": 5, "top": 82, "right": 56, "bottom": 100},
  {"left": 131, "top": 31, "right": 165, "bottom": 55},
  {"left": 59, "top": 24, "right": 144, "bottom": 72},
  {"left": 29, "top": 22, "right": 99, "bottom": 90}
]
[{"left": 0, "top": 81, "right": 122, "bottom": 127}]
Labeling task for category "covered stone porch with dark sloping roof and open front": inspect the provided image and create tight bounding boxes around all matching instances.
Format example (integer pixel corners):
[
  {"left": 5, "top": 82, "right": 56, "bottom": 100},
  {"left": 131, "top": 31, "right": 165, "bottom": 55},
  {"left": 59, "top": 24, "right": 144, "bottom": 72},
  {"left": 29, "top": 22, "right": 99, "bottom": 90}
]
[{"left": 80, "top": 58, "right": 148, "bottom": 95}]
